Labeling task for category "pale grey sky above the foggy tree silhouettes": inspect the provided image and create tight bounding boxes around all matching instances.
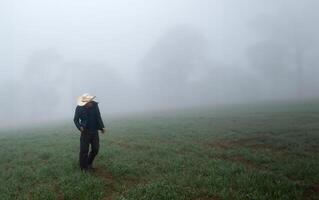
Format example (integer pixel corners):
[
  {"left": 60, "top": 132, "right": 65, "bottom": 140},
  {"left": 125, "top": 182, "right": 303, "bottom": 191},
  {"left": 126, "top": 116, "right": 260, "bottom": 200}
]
[{"left": 5, "top": 0, "right": 275, "bottom": 76}]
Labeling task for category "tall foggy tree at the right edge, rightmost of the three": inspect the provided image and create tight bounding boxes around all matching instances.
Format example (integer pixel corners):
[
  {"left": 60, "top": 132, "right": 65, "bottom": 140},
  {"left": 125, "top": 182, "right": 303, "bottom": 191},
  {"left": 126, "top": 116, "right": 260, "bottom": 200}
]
[{"left": 250, "top": 0, "right": 319, "bottom": 98}]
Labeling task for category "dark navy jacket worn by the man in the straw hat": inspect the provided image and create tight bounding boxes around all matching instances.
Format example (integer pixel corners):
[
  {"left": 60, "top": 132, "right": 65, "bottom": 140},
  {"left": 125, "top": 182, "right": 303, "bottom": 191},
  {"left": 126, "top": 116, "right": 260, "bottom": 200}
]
[{"left": 73, "top": 101, "right": 104, "bottom": 130}]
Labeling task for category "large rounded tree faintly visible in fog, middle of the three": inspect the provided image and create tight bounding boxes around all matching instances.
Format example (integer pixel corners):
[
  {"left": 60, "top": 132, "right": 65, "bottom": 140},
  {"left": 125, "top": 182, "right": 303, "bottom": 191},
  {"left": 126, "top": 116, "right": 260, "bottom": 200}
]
[{"left": 142, "top": 26, "right": 211, "bottom": 107}]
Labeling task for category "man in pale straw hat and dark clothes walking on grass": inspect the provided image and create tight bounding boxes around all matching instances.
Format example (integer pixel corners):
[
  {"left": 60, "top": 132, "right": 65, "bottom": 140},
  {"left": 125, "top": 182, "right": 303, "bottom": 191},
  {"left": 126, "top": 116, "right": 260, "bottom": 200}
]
[{"left": 74, "top": 93, "right": 105, "bottom": 171}]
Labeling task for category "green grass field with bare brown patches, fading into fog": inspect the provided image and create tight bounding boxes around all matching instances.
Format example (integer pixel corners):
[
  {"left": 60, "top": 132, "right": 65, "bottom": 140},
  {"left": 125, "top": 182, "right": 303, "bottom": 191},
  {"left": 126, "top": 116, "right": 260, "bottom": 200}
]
[{"left": 0, "top": 102, "right": 319, "bottom": 200}]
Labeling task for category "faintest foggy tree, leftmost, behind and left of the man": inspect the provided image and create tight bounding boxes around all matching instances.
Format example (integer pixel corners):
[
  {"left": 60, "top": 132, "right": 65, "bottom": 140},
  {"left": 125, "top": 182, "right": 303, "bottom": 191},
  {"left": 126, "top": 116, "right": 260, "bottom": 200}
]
[{"left": 18, "top": 48, "right": 63, "bottom": 120}]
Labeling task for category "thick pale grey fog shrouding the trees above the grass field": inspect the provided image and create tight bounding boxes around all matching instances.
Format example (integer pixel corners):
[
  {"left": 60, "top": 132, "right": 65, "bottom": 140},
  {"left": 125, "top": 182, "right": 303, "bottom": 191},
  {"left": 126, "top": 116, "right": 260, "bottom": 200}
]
[{"left": 0, "top": 0, "right": 319, "bottom": 126}]
